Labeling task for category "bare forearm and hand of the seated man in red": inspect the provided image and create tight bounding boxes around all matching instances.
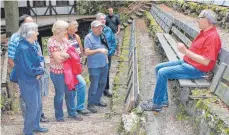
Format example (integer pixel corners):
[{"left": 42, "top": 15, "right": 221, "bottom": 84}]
[{"left": 177, "top": 43, "right": 210, "bottom": 66}]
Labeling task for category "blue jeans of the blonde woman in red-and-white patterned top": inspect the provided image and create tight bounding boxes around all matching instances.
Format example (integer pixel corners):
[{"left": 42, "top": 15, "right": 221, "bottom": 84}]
[{"left": 50, "top": 72, "right": 77, "bottom": 120}]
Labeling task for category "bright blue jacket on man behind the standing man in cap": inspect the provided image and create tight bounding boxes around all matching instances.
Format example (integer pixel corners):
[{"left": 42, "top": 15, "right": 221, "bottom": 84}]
[{"left": 89, "top": 25, "right": 116, "bottom": 56}]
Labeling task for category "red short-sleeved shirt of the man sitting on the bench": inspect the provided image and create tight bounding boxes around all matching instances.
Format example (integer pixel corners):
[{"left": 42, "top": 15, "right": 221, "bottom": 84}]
[{"left": 184, "top": 27, "right": 221, "bottom": 72}]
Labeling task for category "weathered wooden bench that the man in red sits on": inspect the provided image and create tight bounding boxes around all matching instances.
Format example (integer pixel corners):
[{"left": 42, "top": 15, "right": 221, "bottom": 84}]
[{"left": 151, "top": 5, "right": 229, "bottom": 105}]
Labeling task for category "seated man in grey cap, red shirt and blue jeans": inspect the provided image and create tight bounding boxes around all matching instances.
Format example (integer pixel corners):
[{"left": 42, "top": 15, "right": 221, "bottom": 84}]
[{"left": 141, "top": 10, "right": 221, "bottom": 112}]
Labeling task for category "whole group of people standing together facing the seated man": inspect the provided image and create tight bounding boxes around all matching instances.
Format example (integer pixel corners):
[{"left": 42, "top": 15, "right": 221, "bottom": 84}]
[{"left": 8, "top": 8, "right": 120, "bottom": 135}]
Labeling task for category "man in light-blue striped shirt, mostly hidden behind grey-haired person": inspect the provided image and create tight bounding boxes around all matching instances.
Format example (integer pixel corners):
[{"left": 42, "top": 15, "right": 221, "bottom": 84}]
[{"left": 8, "top": 14, "right": 48, "bottom": 122}]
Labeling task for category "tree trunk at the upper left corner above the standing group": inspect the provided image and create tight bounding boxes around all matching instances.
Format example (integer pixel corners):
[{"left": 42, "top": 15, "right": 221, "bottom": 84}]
[{"left": 4, "top": 1, "right": 19, "bottom": 37}]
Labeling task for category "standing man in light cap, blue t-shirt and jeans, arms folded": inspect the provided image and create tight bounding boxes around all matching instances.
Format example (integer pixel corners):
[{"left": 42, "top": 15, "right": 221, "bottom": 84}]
[{"left": 84, "top": 20, "right": 108, "bottom": 113}]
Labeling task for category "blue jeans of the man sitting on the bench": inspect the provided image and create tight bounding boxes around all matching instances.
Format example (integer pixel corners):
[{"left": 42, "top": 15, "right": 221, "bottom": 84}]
[{"left": 153, "top": 60, "right": 205, "bottom": 105}]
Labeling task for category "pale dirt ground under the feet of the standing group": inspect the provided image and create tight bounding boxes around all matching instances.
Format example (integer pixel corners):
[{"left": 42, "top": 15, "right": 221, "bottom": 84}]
[{"left": 1, "top": 32, "right": 123, "bottom": 135}]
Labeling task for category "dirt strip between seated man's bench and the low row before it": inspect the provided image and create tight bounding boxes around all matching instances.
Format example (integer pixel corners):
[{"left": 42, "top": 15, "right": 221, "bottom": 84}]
[{"left": 136, "top": 20, "right": 195, "bottom": 135}]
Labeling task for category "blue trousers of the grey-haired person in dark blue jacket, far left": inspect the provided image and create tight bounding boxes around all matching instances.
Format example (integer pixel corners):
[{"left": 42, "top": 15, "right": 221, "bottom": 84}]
[{"left": 18, "top": 79, "right": 41, "bottom": 134}]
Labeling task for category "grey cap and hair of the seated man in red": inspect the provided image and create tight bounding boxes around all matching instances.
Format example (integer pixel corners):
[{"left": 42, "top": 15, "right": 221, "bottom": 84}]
[{"left": 199, "top": 9, "right": 217, "bottom": 24}]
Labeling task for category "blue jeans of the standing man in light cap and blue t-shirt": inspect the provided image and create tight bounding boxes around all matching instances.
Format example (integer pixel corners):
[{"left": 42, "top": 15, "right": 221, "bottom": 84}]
[{"left": 88, "top": 65, "right": 108, "bottom": 105}]
